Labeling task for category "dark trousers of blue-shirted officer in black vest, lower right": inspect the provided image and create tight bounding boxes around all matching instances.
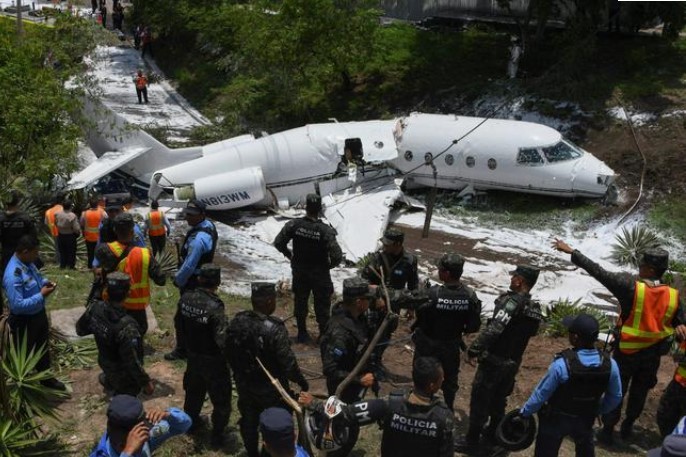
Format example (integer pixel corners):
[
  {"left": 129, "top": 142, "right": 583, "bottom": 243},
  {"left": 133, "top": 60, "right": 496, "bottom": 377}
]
[{"left": 534, "top": 412, "right": 595, "bottom": 457}]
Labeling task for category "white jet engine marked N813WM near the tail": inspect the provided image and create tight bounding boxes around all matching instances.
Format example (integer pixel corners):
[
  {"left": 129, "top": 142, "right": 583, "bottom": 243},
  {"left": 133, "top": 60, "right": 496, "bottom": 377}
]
[{"left": 174, "top": 167, "right": 266, "bottom": 210}]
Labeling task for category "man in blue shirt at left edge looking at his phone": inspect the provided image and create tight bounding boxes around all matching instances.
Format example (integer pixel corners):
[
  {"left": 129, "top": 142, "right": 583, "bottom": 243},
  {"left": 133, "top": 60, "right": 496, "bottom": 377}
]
[{"left": 2, "top": 235, "right": 66, "bottom": 390}]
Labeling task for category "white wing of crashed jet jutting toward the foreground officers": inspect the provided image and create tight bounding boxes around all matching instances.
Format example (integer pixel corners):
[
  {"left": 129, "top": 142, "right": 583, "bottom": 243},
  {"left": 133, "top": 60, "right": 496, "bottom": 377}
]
[{"left": 322, "top": 178, "right": 404, "bottom": 262}]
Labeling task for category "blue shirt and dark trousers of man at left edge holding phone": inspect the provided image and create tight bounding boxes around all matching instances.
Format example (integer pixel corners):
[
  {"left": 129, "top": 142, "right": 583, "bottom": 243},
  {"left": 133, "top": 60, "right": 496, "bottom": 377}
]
[{"left": 2, "top": 254, "right": 50, "bottom": 371}]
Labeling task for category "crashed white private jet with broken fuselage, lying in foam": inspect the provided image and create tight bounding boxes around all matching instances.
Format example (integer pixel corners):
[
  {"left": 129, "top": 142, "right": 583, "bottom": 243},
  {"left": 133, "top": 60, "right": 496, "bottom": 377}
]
[{"left": 70, "top": 96, "right": 615, "bottom": 260}]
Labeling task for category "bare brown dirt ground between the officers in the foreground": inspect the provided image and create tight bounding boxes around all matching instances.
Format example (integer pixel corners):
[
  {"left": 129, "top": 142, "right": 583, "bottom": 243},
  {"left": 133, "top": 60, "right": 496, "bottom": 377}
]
[{"left": 57, "top": 308, "right": 674, "bottom": 457}]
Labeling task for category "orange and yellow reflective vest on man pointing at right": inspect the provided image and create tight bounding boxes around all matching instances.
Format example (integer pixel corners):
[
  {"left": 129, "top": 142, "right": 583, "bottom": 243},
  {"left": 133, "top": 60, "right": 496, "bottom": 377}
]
[{"left": 619, "top": 281, "right": 679, "bottom": 354}]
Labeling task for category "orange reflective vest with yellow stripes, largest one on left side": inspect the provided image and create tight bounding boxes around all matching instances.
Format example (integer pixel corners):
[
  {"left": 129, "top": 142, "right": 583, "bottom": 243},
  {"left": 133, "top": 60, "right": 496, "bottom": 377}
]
[{"left": 107, "top": 241, "right": 150, "bottom": 309}]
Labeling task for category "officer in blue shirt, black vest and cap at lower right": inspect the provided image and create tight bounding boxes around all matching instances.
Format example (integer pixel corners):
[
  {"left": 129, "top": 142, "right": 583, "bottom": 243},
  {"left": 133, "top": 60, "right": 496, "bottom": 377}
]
[{"left": 520, "top": 314, "right": 622, "bottom": 457}]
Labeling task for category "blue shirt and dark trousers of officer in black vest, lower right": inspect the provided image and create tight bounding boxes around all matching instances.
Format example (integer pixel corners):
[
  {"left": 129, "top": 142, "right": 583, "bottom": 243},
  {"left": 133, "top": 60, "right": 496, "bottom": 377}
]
[{"left": 521, "top": 349, "right": 622, "bottom": 456}]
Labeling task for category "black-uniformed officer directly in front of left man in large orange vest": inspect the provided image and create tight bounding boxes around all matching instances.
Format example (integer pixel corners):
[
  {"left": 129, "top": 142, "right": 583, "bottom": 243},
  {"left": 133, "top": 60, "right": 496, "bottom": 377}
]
[{"left": 76, "top": 272, "right": 155, "bottom": 396}]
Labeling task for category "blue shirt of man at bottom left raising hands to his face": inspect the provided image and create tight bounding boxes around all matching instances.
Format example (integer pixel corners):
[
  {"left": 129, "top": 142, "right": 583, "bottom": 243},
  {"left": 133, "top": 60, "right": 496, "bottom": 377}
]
[{"left": 89, "top": 408, "right": 193, "bottom": 457}]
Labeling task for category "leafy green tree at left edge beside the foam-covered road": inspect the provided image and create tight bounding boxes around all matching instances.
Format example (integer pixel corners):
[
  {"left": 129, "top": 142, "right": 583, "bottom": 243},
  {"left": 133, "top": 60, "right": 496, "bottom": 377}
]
[{"left": 0, "top": 19, "right": 88, "bottom": 197}]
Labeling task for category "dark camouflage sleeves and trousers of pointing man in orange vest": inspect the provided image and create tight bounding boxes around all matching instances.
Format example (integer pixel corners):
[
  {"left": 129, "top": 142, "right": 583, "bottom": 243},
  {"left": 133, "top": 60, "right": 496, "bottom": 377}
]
[{"left": 572, "top": 250, "right": 686, "bottom": 433}]
